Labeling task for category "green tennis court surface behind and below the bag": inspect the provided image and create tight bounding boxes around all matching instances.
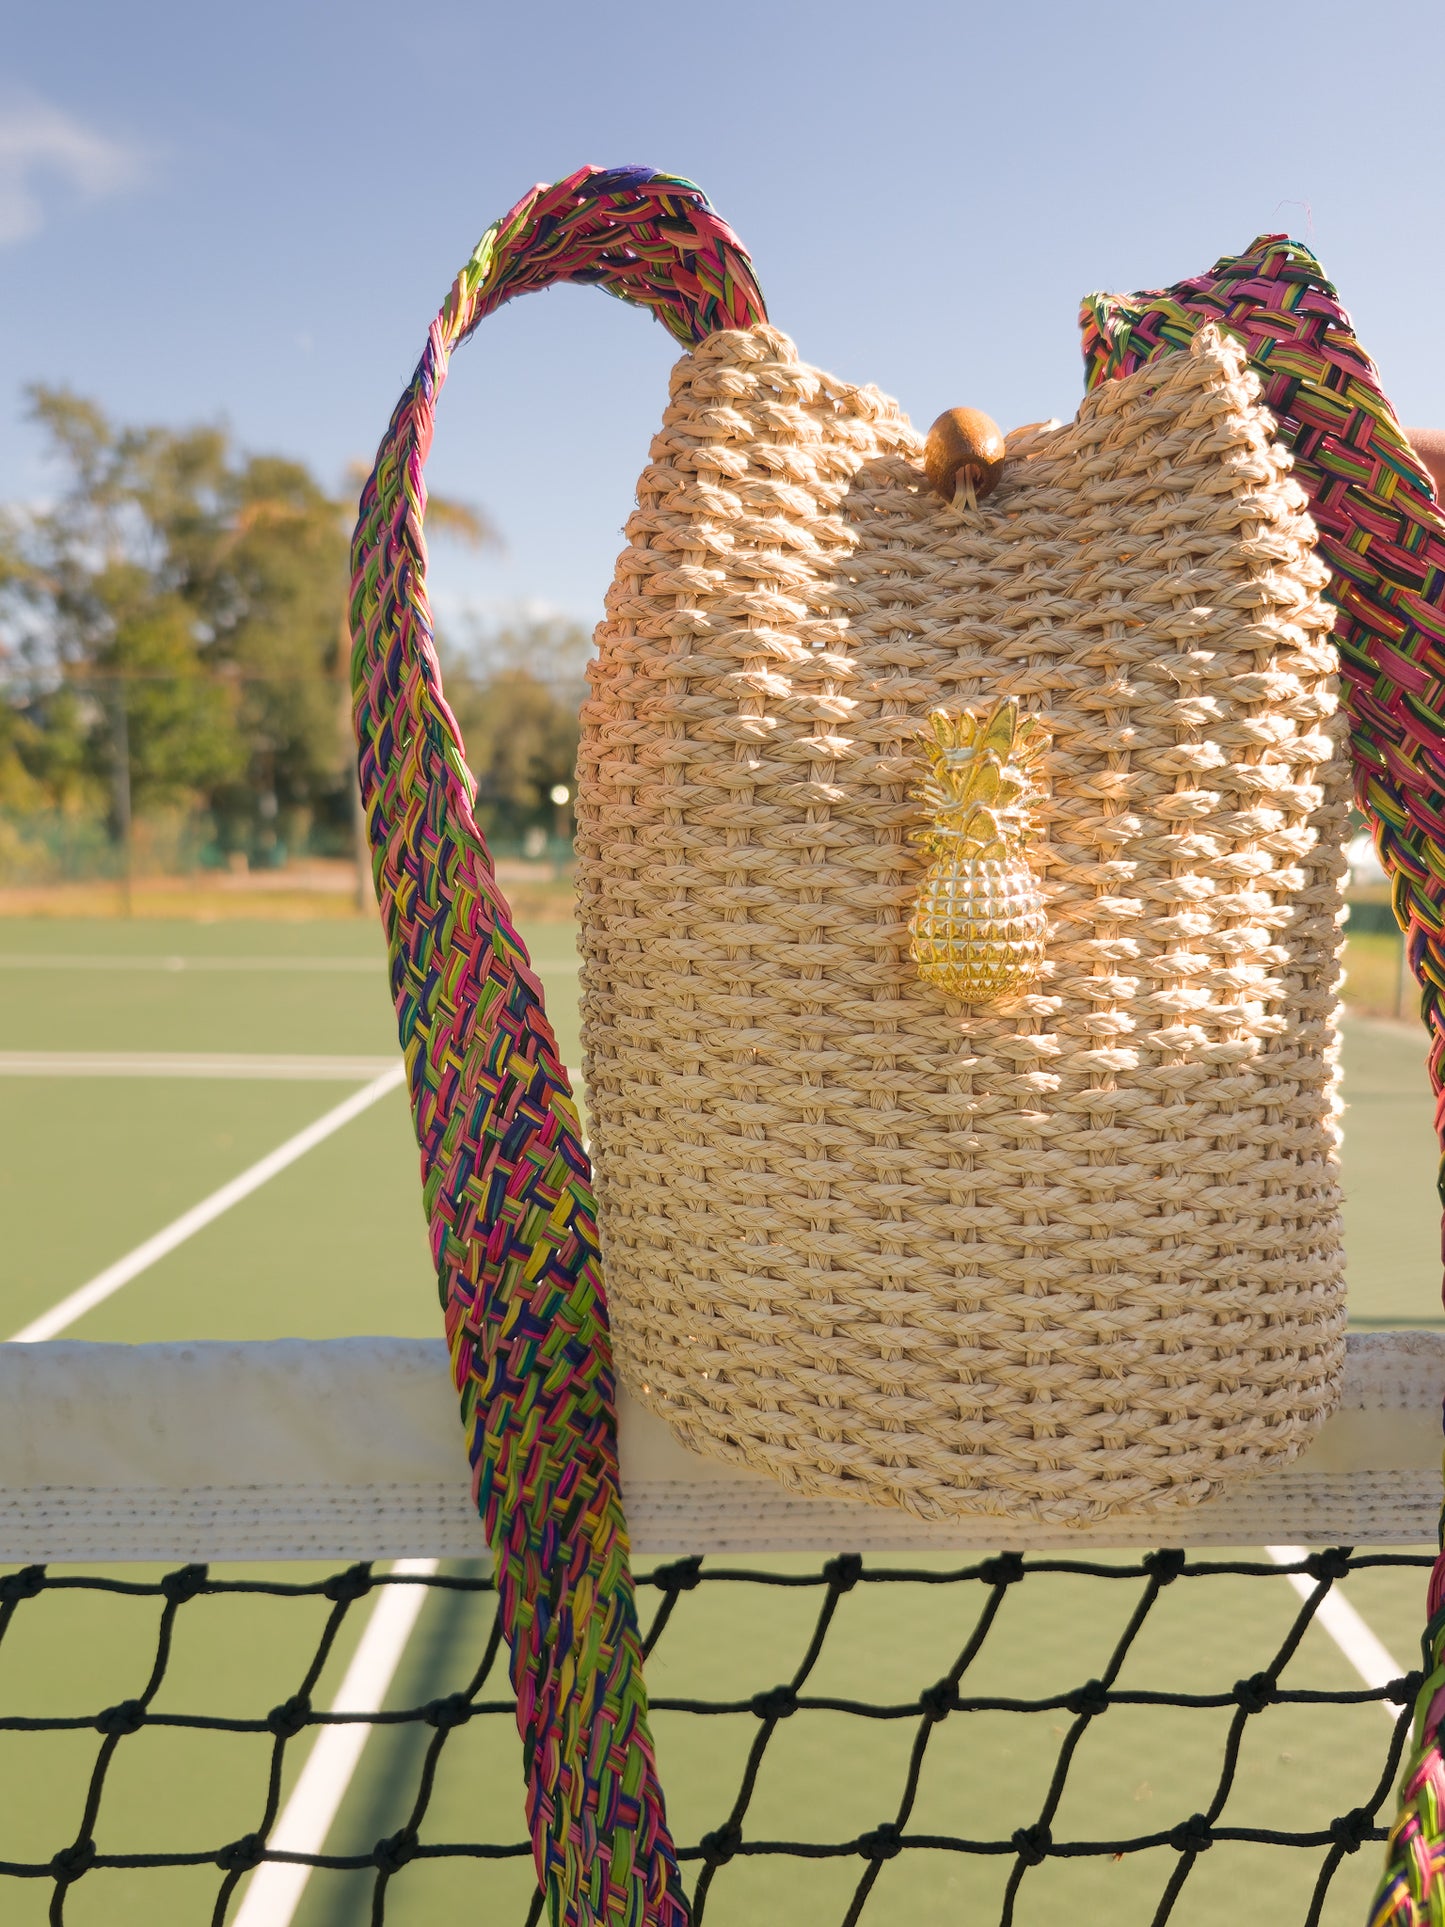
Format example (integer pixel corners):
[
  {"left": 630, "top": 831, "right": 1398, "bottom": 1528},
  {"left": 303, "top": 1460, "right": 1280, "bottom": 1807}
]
[{"left": 0, "top": 919, "right": 1441, "bottom": 1927}]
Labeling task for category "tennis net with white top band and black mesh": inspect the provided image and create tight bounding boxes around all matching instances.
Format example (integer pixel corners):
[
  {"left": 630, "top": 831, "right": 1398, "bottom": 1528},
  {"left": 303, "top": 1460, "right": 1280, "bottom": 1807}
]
[{"left": 0, "top": 1333, "right": 1439, "bottom": 1927}]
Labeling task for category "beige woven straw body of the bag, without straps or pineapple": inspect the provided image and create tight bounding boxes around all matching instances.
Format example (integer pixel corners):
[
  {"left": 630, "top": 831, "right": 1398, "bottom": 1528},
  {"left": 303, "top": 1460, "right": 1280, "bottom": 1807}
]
[{"left": 578, "top": 326, "right": 1347, "bottom": 1522}]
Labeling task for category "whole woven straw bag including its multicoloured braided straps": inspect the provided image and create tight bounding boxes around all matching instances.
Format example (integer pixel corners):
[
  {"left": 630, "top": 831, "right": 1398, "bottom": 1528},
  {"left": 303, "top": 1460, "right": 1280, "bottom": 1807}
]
[{"left": 353, "top": 170, "right": 1445, "bottom": 1923}]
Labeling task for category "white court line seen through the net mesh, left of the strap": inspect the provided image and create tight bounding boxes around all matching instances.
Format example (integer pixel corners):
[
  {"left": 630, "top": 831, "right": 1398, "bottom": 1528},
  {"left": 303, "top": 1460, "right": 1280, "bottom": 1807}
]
[{"left": 231, "top": 1559, "right": 437, "bottom": 1927}]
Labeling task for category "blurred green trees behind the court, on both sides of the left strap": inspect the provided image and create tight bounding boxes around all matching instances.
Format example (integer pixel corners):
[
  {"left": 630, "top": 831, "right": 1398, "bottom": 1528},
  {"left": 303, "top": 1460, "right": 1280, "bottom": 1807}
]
[{"left": 0, "top": 387, "right": 590, "bottom": 881}]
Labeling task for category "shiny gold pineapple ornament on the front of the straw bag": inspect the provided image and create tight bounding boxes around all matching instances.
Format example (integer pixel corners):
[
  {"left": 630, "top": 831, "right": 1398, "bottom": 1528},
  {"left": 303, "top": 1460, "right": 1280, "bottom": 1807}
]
[{"left": 907, "top": 696, "right": 1048, "bottom": 1004}]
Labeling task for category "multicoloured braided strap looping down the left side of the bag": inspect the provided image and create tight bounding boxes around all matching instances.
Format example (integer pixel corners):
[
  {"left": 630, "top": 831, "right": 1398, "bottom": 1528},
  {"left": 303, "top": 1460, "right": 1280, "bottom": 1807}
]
[{"left": 351, "top": 168, "right": 765, "bottom": 1927}]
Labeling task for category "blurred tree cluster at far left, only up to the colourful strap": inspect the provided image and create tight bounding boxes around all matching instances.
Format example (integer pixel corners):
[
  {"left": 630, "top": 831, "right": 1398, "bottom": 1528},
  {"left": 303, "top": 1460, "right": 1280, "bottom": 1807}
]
[{"left": 0, "top": 387, "right": 351, "bottom": 846}]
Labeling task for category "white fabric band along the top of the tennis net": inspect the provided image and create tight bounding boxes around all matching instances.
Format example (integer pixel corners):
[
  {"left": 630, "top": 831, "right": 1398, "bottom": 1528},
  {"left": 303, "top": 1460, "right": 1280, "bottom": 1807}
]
[{"left": 0, "top": 1332, "right": 1445, "bottom": 1563}]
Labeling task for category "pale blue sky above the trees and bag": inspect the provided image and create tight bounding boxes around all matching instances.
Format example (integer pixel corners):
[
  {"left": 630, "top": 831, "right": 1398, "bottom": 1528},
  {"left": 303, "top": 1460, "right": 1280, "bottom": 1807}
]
[{"left": 0, "top": 0, "right": 1445, "bottom": 622}]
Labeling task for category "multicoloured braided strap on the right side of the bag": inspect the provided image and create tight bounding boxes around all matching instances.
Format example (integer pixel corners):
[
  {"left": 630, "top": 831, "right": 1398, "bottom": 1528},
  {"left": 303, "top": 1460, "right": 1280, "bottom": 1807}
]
[{"left": 1083, "top": 235, "right": 1445, "bottom": 1927}]
